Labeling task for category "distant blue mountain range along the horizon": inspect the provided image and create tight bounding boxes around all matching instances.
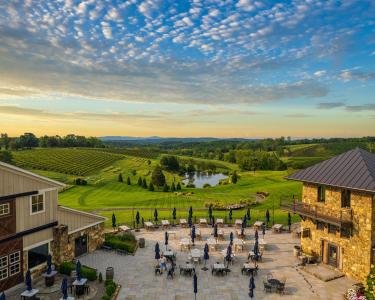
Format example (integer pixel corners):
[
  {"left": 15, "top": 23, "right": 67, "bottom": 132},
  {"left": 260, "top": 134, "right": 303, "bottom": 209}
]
[{"left": 99, "top": 136, "right": 256, "bottom": 144}]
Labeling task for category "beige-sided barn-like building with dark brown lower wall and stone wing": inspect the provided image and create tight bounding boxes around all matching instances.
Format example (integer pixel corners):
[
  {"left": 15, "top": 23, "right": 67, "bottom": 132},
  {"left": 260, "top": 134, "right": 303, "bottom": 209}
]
[{"left": 0, "top": 162, "right": 106, "bottom": 292}]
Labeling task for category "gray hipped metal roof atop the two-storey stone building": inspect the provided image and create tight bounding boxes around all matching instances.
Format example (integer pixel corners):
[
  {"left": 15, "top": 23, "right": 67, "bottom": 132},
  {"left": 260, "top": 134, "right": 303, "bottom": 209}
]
[{"left": 285, "top": 148, "right": 375, "bottom": 193}]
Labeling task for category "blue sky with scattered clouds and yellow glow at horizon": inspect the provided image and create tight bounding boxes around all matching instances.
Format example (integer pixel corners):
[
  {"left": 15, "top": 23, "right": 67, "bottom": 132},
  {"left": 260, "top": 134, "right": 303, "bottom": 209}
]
[{"left": 0, "top": 0, "right": 375, "bottom": 138}]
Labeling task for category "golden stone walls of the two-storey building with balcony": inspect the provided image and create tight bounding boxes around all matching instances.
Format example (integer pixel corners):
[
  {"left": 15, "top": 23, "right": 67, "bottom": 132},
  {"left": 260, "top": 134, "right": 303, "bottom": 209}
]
[{"left": 301, "top": 184, "right": 374, "bottom": 280}]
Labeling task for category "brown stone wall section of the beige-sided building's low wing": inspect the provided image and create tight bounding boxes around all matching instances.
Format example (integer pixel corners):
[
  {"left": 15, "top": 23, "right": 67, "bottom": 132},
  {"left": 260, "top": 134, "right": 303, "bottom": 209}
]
[{"left": 51, "top": 223, "right": 104, "bottom": 264}]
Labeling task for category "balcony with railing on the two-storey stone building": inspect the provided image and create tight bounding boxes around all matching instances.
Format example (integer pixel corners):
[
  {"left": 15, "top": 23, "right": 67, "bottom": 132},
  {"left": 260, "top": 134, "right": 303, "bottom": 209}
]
[{"left": 280, "top": 199, "right": 353, "bottom": 227}]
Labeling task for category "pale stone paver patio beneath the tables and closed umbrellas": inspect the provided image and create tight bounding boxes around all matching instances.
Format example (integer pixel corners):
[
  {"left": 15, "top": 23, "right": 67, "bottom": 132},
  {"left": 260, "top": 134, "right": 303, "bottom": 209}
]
[{"left": 80, "top": 227, "right": 355, "bottom": 300}]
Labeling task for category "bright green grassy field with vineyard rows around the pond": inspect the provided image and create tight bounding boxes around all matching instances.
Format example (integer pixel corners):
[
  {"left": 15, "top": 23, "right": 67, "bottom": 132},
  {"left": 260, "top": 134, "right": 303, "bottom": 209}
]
[{"left": 14, "top": 149, "right": 301, "bottom": 226}]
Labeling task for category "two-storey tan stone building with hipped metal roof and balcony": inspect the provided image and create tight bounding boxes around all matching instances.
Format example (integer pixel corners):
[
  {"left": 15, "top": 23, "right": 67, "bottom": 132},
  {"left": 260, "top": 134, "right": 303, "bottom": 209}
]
[{"left": 281, "top": 148, "right": 375, "bottom": 280}]
